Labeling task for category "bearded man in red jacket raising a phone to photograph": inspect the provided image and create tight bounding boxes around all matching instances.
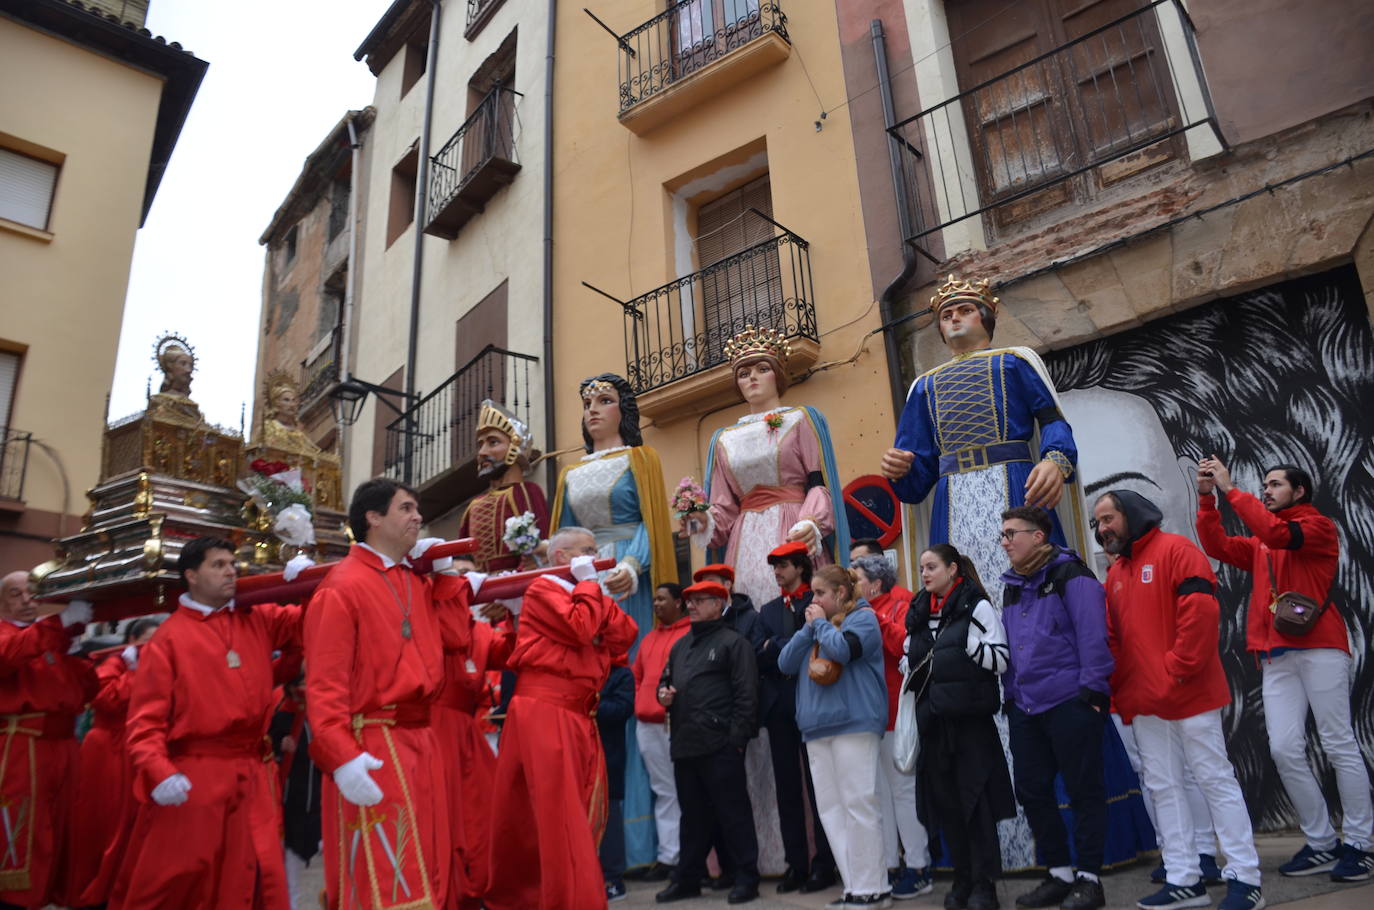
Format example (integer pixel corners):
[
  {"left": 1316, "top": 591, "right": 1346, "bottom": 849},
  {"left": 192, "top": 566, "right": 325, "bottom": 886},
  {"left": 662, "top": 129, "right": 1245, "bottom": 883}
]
[{"left": 1198, "top": 455, "right": 1374, "bottom": 881}]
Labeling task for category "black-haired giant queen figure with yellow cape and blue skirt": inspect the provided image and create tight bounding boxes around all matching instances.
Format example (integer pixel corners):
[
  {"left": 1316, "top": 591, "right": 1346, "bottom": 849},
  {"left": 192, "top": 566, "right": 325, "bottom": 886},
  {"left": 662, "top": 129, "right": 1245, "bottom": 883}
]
[{"left": 550, "top": 373, "right": 677, "bottom": 867}]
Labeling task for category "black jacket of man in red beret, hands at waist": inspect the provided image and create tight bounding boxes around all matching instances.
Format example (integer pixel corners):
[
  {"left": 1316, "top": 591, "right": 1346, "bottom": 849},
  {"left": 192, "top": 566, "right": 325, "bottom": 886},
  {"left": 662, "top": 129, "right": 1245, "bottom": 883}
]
[{"left": 660, "top": 620, "right": 758, "bottom": 760}]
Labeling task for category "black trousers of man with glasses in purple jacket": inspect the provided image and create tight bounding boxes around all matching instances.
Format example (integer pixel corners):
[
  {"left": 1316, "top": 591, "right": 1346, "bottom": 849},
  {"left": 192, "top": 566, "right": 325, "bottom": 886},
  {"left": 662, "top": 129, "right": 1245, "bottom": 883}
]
[{"left": 1007, "top": 698, "right": 1107, "bottom": 874}]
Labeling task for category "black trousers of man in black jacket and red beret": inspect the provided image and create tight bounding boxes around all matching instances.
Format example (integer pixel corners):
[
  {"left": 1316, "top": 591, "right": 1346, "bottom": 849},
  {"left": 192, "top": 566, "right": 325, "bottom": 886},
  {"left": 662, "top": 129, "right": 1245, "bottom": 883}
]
[{"left": 673, "top": 746, "right": 758, "bottom": 885}]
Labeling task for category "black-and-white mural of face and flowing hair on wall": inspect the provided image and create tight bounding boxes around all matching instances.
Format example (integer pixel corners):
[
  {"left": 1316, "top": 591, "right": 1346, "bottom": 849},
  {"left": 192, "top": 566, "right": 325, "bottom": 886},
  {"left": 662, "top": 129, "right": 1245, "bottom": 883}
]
[{"left": 1046, "top": 265, "right": 1374, "bottom": 829}]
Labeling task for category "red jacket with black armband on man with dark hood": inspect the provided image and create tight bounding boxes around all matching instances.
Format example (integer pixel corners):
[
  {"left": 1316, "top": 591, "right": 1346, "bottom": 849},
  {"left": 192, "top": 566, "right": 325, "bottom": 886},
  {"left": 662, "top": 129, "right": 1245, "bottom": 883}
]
[{"left": 1107, "top": 528, "right": 1231, "bottom": 723}]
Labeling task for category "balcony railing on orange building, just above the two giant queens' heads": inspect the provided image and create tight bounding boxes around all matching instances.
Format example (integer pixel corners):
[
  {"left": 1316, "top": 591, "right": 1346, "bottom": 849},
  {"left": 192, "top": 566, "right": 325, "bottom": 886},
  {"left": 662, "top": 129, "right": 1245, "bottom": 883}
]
[{"left": 617, "top": 216, "right": 820, "bottom": 393}]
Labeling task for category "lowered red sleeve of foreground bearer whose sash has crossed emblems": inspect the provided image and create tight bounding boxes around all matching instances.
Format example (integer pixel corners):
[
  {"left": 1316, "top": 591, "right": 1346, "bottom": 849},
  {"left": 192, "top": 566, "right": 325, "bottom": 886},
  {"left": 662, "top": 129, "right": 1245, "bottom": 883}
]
[{"left": 303, "top": 588, "right": 361, "bottom": 773}]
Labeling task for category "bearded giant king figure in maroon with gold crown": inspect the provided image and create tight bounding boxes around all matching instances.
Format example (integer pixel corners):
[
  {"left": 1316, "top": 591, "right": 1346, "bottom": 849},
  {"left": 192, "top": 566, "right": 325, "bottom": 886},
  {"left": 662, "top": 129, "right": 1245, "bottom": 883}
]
[{"left": 458, "top": 399, "right": 548, "bottom": 572}]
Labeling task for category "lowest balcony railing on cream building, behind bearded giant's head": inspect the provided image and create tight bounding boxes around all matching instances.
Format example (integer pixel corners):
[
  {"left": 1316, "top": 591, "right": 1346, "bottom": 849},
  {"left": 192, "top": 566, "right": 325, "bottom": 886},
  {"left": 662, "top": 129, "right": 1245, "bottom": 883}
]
[{"left": 385, "top": 345, "right": 543, "bottom": 487}]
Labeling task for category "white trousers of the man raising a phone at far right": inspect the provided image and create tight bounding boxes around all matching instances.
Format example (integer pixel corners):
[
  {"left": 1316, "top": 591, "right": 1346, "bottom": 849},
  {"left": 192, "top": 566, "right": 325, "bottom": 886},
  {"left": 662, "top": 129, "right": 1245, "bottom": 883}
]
[{"left": 1264, "top": 647, "right": 1374, "bottom": 850}]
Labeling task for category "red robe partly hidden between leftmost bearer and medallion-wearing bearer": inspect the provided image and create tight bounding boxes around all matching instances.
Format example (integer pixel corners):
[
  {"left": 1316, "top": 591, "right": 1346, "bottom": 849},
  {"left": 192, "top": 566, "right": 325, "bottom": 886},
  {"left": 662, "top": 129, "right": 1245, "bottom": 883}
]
[{"left": 69, "top": 654, "right": 137, "bottom": 907}]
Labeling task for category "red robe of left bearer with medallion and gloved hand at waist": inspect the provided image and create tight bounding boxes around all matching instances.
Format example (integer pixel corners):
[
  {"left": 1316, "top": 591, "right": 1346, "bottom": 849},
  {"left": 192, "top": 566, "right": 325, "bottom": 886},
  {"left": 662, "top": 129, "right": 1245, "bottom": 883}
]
[{"left": 110, "top": 598, "right": 301, "bottom": 910}]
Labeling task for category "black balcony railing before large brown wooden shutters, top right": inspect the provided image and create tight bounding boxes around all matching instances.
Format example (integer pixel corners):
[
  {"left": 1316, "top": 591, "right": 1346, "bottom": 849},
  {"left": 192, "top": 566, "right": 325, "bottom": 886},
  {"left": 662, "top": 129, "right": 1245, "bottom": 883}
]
[{"left": 888, "top": 0, "right": 1226, "bottom": 260}]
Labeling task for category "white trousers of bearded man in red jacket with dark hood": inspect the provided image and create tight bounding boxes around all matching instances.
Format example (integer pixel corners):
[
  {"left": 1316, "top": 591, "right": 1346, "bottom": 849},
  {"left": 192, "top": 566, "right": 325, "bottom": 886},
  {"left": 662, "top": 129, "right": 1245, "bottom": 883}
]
[{"left": 1132, "top": 709, "right": 1260, "bottom": 885}]
